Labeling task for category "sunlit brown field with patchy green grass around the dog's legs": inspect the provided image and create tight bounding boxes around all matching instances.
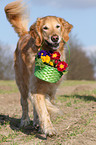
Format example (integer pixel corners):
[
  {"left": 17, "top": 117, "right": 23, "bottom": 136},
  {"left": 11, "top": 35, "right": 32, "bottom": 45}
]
[{"left": 0, "top": 81, "right": 96, "bottom": 145}]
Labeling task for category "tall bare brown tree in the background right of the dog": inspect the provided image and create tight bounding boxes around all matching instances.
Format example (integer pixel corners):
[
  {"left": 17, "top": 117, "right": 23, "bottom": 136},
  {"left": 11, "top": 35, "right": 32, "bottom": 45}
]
[{"left": 67, "top": 37, "right": 94, "bottom": 80}]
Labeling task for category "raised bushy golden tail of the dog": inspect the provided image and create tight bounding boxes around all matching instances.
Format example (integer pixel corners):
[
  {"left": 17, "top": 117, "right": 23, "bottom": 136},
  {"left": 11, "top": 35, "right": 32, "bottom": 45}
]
[{"left": 5, "top": 0, "right": 29, "bottom": 37}]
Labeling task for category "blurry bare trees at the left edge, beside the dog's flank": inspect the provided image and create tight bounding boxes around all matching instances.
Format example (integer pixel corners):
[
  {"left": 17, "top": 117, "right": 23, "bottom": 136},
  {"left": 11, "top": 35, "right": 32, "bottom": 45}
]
[{"left": 0, "top": 43, "right": 14, "bottom": 80}]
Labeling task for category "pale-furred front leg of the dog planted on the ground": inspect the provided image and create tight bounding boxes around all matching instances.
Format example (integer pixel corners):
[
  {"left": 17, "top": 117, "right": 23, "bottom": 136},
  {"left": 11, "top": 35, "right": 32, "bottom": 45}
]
[{"left": 33, "top": 94, "right": 56, "bottom": 136}]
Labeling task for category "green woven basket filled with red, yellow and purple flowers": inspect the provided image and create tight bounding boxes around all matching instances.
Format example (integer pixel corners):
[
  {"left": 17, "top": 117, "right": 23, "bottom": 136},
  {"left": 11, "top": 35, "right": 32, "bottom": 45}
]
[{"left": 34, "top": 50, "right": 68, "bottom": 83}]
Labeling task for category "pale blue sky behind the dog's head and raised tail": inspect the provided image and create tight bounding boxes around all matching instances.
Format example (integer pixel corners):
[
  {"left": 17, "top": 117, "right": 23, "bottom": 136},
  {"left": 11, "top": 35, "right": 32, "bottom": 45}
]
[{"left": 0, "top": 0, "right": 96, "bottom": 51}]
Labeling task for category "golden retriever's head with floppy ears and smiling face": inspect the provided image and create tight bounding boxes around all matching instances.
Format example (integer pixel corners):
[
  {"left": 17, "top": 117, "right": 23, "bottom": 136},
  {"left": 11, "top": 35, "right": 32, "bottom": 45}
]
[{"left": 30, "top": 16, "right": 73, "bottom": 50}]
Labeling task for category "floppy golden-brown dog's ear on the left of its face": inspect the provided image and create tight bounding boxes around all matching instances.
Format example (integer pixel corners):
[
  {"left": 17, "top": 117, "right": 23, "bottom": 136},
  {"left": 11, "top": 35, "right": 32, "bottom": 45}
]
[{"left": 30, "top": 18, "right": 42, "bottom": 46}]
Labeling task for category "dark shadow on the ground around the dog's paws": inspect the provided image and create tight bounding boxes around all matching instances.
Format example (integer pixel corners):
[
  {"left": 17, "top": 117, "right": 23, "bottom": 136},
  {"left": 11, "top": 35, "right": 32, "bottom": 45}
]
[{"left": 0, "top": 115, "right": 46, "bottom": 140}]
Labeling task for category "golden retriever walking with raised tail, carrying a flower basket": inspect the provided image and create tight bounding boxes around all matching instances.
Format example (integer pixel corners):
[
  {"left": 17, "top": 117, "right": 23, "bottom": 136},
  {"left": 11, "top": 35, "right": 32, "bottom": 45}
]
[{"left": 5, "top": 1, "right": 72, "bottom": 136}]
